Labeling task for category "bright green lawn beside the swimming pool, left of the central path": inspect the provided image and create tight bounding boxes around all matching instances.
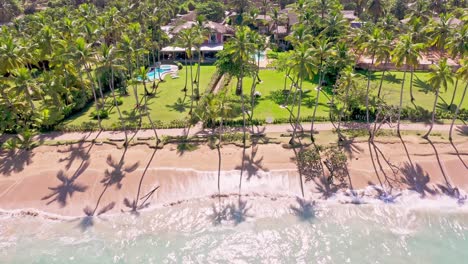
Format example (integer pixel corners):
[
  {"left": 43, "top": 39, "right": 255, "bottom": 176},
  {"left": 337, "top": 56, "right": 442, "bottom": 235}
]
[{"left": 64, "top": 66, "right": 216, "bottom": 128}]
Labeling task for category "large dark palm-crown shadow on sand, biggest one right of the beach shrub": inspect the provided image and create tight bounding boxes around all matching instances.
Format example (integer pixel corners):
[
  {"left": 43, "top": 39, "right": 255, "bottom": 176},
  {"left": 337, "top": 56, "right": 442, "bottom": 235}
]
[{"left": 400, "top": 162, "right": 437, "bottom": 198}]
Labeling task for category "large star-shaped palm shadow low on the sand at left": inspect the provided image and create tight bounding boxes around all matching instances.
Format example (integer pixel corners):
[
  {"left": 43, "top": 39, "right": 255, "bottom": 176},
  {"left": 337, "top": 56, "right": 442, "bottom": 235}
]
[{"left": 42, "top": 162, "right": 89, "bottom": 207}]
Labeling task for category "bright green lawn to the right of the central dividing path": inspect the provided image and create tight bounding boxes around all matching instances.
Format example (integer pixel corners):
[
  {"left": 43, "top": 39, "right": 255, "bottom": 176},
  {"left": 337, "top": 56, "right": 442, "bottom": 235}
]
[{"left": 224, "top": 70, "right": 468, "bottom": 124}]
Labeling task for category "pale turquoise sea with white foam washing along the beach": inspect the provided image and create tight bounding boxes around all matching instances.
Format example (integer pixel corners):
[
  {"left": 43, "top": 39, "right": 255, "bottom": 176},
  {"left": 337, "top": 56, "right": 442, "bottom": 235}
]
[{"left": 0, "top": 197, "right": 468, "bottom": 263}]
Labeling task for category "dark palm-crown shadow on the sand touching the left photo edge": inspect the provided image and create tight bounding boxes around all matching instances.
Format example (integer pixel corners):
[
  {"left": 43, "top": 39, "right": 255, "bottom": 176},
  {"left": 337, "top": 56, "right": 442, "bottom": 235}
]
[{"left": 0, "top": 150, "right": 34, "bottom": 176}]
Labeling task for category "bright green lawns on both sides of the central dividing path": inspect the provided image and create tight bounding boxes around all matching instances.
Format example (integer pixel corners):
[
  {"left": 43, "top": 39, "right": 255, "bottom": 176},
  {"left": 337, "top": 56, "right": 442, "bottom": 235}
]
[{"left": 64, "top": 66, "right": 468, "bottom": 128}]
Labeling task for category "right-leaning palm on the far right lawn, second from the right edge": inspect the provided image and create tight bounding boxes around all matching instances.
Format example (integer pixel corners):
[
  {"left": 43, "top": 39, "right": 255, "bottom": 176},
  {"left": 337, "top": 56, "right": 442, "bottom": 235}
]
[{"left": 423, "top": 58, "right": 453, "bottom": 139}]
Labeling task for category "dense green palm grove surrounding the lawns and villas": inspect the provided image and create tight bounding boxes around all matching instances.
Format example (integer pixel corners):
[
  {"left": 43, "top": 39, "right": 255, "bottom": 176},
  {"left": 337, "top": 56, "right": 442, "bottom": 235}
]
[{"left": 0, "top": 0, "right": 468, "bottom": 144}]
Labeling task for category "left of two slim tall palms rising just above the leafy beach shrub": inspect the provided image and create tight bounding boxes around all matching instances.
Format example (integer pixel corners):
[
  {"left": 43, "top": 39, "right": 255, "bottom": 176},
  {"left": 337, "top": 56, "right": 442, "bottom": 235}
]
[{"left": 289, "top": 43, "right": 315, "bottom": 145}]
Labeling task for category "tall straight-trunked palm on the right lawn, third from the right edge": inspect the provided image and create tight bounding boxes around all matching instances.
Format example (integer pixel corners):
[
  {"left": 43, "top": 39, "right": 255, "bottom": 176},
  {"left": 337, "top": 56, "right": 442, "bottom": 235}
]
[{"left": 392, "top": 35, "right": 424, "bottom": 135}]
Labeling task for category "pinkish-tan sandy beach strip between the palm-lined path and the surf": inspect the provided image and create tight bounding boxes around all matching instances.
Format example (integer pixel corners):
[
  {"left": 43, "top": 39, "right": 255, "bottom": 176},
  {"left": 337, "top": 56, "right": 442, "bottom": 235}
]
[{"left": 0, "top": 136, "right": 468, "bottom": 216}]
